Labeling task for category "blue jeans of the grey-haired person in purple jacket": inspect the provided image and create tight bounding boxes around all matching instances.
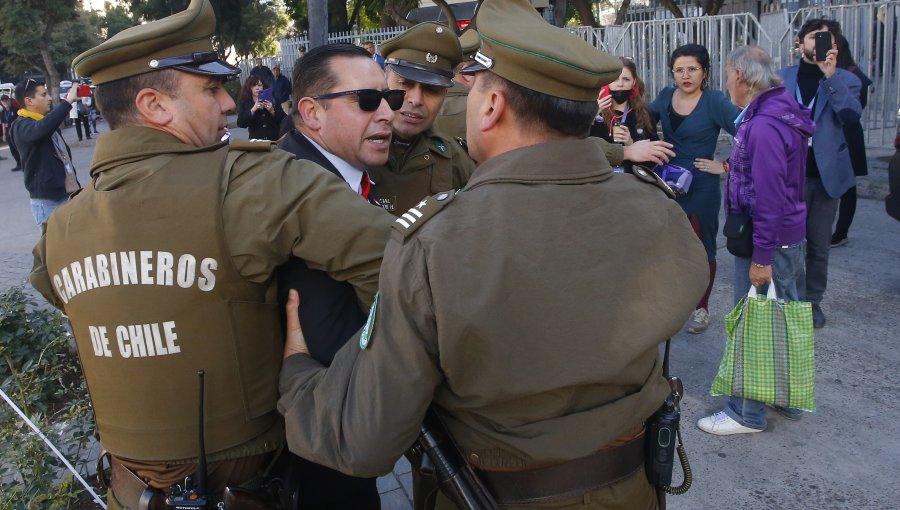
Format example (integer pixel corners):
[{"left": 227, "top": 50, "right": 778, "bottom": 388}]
[{"left": 725, "top": 243, "right": 806, "bottom": 430}]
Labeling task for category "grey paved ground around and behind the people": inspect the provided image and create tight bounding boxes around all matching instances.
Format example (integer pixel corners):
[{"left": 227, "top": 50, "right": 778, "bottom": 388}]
[{"left": 0, "top": 116, "right": 900, "bottom": 510}]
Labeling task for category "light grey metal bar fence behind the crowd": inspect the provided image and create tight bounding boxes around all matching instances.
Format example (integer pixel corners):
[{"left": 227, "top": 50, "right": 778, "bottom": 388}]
[{"left": 255, "top": 0, "right": 900, "bottom": 146}]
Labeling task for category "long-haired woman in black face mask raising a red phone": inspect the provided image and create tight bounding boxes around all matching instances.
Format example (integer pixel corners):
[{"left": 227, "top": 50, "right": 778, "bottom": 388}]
[{"left": 590, "top": 57, "right": 659, "bottom": 173}]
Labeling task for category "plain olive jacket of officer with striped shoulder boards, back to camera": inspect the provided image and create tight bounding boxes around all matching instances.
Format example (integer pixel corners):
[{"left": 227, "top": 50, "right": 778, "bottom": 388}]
[{"left": 278, "top": 139, "right": 709, "bottom": 507}]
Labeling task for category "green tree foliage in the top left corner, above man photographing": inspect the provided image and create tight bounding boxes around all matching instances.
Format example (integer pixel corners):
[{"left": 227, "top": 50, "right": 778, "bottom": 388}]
[{"left": 0, "top": 0, "right": 97, "bottom": 95}]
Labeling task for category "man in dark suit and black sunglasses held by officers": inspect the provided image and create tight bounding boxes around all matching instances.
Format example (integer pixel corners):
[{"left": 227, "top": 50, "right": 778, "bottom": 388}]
[{"left": 278, "top": 44, "right": 403, "bottom": 509}]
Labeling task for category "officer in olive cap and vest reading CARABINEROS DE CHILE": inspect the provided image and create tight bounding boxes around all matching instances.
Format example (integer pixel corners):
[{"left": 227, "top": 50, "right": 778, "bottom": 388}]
[{"left": 30, "top": 0, "right": 392, "bottom": 509}]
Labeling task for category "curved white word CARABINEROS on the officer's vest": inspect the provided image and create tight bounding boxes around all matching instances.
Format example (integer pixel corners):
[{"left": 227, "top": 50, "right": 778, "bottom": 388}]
[{"left": 51, "top": 250, "right": 219, "bottom": 304}]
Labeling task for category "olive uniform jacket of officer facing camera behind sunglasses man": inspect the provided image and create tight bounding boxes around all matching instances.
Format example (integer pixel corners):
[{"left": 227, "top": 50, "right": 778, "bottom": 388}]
[{"left": 369, "top": 129, "right": 475, "bottom": 216}]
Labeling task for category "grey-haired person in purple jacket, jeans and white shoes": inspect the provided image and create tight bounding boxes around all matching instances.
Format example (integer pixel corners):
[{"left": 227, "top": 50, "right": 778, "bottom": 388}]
[{"left": 697, "top": 46, "right": 815, "bottom": 435}]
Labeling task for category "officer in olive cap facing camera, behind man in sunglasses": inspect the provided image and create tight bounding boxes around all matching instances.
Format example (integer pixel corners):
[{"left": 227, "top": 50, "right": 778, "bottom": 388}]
[{"left": 370, "top": 23, "right": 475, "bottom": 215}]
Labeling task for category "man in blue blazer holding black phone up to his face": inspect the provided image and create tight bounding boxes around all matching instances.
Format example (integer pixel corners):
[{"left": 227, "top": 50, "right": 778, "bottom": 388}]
[{"left": 778, "top": 19, "right": 862, "bottom": 328}]
